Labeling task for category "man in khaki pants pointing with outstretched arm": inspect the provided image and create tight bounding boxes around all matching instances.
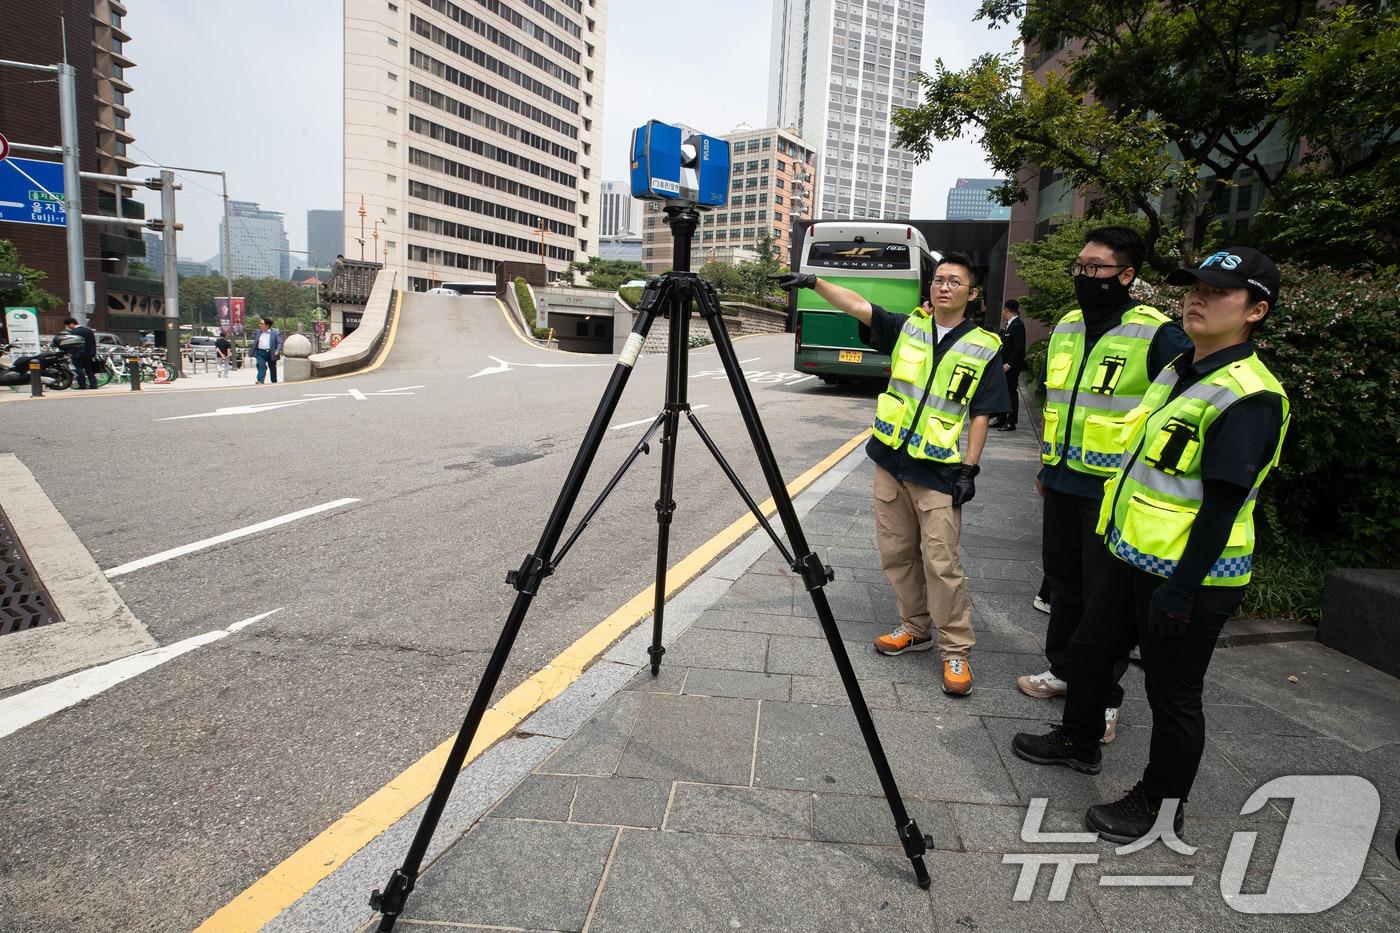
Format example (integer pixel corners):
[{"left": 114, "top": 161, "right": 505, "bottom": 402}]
[{"left": 778, "top": 252, "right": 1007, "bottom": 696}]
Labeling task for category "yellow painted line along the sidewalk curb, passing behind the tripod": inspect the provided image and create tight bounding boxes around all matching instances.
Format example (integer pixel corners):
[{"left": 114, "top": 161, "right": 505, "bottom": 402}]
[{"left": 195, "top": 431, "right": 869, "bottom": 933}]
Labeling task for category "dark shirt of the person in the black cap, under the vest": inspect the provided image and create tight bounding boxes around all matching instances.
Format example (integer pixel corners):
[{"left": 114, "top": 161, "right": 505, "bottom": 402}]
[{"left": 1170, "top": 340, "right": 1284, "bottom": 489}]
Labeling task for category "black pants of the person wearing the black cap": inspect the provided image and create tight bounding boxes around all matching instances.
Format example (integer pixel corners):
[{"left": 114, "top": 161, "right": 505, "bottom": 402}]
[{"left": 1064, "top": 559, "right": 1245, "bottom": 801}]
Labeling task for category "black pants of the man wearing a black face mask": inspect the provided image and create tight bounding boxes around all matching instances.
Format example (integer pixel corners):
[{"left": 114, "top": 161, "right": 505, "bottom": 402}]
[{"left": 1040, "top": 489, "right": 1133, "bottom": 700}]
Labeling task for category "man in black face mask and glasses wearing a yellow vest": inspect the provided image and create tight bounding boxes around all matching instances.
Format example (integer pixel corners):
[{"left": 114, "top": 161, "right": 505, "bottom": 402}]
[{"left": 1016, "top": 227, "right": 1191, "bottom": 742}]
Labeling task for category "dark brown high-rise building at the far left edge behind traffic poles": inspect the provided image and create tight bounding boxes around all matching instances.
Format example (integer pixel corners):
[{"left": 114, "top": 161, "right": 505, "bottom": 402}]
[{"left": 0, "top": 0, "right": 157, "bottom": 336}]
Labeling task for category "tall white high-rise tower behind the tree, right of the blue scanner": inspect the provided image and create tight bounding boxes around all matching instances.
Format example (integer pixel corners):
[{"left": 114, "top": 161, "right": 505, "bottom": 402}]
[{"left": 769, "top": 0, "right": 924, "bottom": 219}]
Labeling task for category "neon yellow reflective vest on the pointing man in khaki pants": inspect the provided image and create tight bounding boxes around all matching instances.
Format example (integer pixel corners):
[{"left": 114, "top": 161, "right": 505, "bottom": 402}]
[{"left": 871, "top": 310, "right": 1001, "bottom": 464}]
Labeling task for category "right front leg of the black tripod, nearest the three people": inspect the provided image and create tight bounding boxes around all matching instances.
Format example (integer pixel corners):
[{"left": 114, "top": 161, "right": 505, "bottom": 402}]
[{"left": 697, "top": 289, "right": 934, "bottom": 888}]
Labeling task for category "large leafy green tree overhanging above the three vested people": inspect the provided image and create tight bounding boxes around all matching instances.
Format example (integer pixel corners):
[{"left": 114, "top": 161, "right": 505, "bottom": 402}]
[{"left": 895, "top": 0, "right": 1348, "bottom": 270}]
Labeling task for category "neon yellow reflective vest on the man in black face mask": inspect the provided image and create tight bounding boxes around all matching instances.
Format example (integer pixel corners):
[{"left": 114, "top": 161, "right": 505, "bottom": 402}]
[{"left": 1040, "top": 305, "right": 1168, "bottom": 476}]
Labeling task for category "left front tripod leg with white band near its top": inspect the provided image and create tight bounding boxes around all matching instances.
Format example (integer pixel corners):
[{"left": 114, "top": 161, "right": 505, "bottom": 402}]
[{"left": 370, "top": 298, "right": 669, "bottom": 932}]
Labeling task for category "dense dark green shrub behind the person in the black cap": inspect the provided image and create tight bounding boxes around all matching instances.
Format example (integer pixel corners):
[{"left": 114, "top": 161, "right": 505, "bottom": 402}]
[{"left": 1254, "top": 266, "right": 1400, "bottom": 567}]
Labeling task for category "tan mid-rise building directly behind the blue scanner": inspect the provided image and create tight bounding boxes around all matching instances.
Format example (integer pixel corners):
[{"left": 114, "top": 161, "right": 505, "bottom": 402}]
[{"left": 641, "top": 126, "right": 816, "bottom": 272}]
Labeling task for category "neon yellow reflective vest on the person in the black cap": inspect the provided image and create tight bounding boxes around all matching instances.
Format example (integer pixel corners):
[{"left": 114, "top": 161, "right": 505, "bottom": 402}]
[{"left": 1099, "top": 356, "right": 1288, "bottom": 587}]
